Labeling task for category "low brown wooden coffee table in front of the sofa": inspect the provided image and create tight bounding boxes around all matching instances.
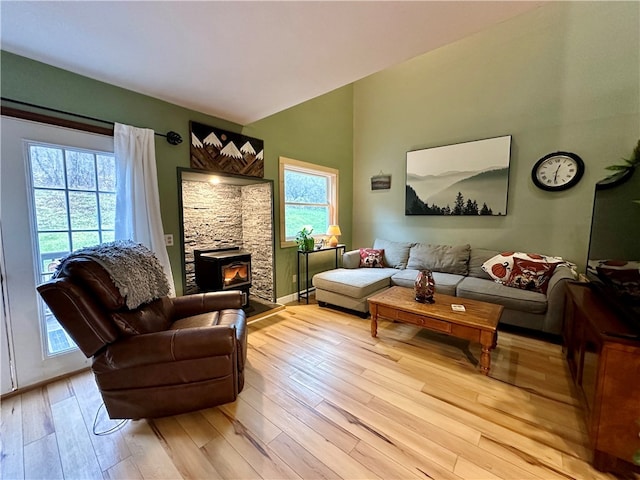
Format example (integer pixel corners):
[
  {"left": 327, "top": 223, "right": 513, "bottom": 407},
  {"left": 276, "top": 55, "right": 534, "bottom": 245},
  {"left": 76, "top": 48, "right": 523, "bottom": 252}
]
[{"left": 368, "top": 287, "right": 504, "bottom": 375}]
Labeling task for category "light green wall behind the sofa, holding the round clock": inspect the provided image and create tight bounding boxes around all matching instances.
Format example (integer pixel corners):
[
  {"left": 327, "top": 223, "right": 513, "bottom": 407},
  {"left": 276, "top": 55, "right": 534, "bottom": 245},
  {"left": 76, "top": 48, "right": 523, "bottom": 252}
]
[{"left": 353, "top": 2, "right": 640, "bottom": 268}]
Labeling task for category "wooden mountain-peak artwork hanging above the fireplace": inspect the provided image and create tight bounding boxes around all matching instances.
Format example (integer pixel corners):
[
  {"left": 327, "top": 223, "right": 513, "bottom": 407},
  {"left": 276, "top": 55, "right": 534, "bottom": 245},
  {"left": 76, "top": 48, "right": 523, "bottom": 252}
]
[{"left": 189, "top": 122, "right": 264, "bottom": 178}]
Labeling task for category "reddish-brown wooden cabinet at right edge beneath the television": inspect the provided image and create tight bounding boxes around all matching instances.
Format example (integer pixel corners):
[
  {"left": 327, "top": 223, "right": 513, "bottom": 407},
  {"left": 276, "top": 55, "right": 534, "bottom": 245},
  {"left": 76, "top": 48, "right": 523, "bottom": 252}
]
[{"left": 563, "top": 284, "right": 640, "bottom": 473}]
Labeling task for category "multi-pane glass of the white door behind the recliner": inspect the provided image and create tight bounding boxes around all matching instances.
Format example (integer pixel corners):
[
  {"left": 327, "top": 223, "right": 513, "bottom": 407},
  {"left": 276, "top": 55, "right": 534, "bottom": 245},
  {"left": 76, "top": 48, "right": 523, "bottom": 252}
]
[{"left": 27, "top": 142, "right": 116, "bottom": 355}]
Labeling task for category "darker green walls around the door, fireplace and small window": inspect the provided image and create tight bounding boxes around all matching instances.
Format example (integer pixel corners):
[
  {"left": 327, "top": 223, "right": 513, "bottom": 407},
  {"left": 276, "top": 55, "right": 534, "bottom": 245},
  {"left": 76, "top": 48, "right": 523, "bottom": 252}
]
[{"left": 0, "top": 51, "right": 353, "bottom": 297}]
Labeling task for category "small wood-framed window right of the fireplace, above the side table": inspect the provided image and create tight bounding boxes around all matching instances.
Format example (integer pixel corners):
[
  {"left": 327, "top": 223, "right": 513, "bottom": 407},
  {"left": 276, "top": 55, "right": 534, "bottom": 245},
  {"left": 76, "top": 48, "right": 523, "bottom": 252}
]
[{"left": 280, "top": 157, "right": 338, "bottom": 247}]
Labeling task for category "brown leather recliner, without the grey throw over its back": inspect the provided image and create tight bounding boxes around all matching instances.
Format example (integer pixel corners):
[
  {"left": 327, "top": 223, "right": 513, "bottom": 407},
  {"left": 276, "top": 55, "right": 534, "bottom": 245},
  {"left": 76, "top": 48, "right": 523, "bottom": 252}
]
[{"left": 37, "top": 258, "right": 247, "bottom": 419}]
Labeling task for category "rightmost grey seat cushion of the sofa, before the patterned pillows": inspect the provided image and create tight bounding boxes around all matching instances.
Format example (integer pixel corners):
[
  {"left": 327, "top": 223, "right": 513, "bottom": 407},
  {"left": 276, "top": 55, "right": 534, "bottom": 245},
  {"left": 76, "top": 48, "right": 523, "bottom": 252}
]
[{"left": 456, "top": 277, "right": 547, "bottom": 313}]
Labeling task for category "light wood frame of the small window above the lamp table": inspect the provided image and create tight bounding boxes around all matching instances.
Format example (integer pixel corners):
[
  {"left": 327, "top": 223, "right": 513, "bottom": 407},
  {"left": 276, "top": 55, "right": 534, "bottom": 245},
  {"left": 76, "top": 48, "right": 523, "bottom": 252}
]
[{"left": 279, "top": 157, "right": 339, "bottom": 248}]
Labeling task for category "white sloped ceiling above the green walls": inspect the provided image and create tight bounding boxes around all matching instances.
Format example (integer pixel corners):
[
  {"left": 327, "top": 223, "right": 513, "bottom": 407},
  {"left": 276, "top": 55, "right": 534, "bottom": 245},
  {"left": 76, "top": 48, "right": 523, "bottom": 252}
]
[{"left": 0, "top": 0, "right": 544, "bottom": 125}]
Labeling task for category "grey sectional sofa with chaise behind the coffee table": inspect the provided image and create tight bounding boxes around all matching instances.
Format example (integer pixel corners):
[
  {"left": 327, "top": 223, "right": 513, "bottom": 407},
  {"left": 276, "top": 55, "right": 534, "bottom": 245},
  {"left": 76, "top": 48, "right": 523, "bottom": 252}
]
[{"left": 313, "top": 239, "right": 575, "bottom": 335}]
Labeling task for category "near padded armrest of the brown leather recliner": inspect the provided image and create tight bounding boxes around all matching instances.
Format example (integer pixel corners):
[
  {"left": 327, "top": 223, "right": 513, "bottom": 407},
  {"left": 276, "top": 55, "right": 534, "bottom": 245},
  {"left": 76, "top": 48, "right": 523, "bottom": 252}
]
[{"left": 93, "top": 325, "right": 236, "bottom": 373}]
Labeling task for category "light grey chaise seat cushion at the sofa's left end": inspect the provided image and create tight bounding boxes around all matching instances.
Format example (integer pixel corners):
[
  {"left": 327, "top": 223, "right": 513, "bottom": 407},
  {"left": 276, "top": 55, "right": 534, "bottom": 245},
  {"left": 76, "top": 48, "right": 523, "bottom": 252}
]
[{"left": 312, "top": 268, "right": 398, "bottom": 298}]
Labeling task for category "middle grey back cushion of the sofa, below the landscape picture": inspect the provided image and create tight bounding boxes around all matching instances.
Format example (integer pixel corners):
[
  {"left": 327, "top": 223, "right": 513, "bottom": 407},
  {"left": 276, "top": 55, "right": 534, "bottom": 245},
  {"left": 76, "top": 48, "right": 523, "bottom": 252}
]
[{"left": 407, "top": 243, "right": 471, "bottom": 275}]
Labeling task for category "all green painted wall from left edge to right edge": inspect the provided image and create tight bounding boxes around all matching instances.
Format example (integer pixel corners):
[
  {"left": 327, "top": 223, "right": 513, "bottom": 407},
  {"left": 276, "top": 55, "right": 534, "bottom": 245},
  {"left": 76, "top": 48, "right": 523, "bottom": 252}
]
[{"left": 0, "top": 2, "right": 640, "bottom": 298}]
